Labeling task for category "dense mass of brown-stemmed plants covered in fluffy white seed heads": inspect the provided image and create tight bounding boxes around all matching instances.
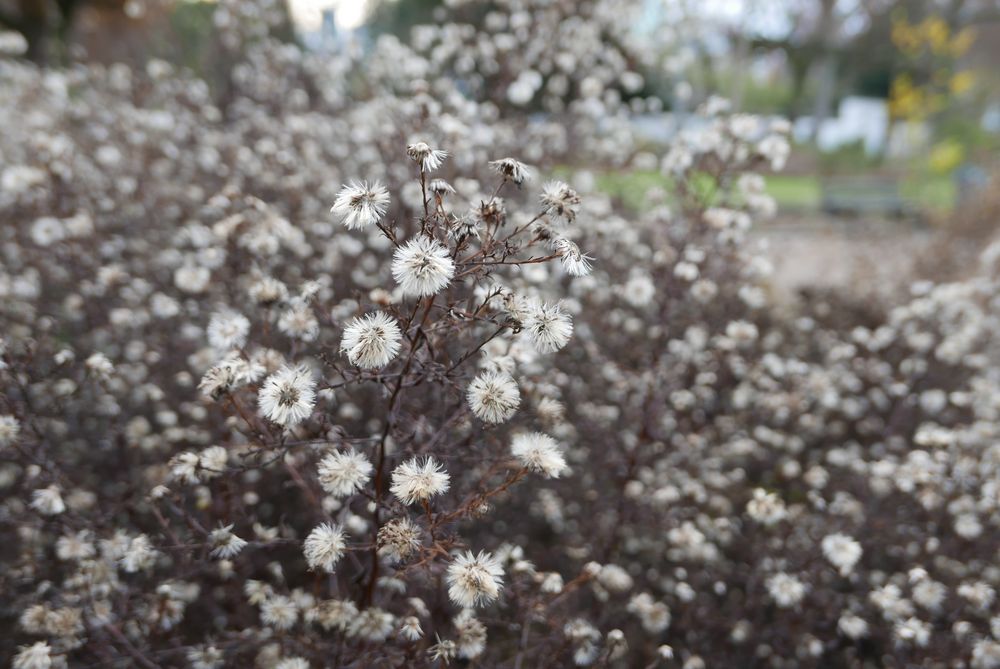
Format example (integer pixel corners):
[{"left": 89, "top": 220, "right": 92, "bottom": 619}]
[{"left": 0, "top": 2, "right": 1000, "bottom": 669}]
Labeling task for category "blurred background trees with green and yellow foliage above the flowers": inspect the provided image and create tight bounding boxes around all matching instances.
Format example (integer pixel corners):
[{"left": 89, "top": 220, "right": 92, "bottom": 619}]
[{"left": 0, "top": 0, "right": 1000, "bottom": 204}]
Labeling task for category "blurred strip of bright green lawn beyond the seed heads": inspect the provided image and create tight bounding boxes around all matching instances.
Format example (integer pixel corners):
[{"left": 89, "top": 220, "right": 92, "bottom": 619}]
[{"left": 597, "top": 171, "right": 955, "bottom": 211}]
